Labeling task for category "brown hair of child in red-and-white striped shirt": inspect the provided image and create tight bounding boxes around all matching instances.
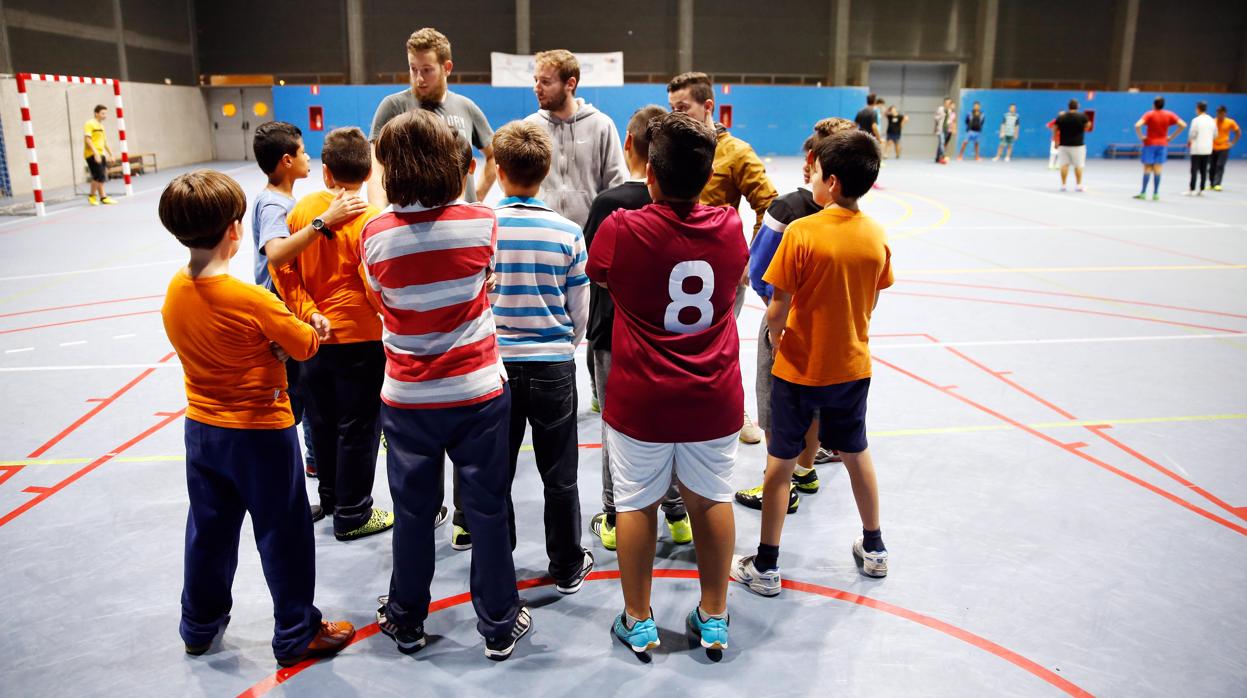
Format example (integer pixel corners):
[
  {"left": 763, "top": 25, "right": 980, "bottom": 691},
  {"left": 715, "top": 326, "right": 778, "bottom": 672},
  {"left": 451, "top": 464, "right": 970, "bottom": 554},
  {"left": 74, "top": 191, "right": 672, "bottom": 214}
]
[{"left": 377, "top": 110, "right": 463, "bottom": 208}]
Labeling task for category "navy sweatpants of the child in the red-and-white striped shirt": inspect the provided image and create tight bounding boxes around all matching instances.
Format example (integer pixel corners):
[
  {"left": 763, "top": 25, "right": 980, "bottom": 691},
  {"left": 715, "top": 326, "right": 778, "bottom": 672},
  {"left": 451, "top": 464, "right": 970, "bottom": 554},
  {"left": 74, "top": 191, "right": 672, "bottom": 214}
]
[{"left": 382, "top": 388, "right": 520, "bottom": 639}]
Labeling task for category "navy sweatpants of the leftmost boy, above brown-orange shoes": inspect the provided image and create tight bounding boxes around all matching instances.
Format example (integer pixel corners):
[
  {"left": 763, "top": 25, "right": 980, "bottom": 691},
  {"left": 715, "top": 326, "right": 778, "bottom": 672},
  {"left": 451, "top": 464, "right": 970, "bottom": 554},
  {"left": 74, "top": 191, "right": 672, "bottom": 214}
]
[{"left": 180, "top": 419, "right": 326, "bottom": 658}]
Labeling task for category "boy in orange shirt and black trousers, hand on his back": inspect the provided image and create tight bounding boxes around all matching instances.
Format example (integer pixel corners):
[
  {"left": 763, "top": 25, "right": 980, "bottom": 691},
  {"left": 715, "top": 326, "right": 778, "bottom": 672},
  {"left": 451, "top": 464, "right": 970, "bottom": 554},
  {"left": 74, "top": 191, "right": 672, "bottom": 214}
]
[{"left": 269, "top": 128, "right": 394, "bottom": 541}]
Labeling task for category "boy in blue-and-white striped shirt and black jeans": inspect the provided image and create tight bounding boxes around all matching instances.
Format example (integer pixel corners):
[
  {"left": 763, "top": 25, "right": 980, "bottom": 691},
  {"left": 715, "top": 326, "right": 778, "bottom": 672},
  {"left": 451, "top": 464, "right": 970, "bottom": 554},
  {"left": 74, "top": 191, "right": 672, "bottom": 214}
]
[{"left": 489, "top": 121, "right": 594, "bottom": 593}]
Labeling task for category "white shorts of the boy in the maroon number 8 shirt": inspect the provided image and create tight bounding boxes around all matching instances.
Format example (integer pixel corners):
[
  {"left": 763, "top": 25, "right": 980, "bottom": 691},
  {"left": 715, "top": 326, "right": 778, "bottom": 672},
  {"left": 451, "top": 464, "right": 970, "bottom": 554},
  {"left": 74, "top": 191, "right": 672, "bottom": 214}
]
[{"left": 602, "top": 424, "right": 739, "bottom": 511}]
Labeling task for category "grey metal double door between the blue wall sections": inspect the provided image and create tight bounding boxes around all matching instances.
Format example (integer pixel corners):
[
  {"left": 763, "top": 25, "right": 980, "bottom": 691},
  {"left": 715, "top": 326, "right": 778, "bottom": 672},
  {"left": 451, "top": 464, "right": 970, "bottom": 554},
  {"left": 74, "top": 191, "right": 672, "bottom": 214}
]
[{"left": 869, "top": 61, "right": 964, "bottom": 160}]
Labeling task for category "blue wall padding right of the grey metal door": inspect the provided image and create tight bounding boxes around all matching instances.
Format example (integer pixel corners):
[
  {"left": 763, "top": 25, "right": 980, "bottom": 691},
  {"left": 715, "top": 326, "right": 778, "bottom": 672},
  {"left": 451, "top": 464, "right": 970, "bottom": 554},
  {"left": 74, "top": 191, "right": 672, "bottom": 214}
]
[{"left": 957, "top": 90, "right": 1247, "bottom": 160}]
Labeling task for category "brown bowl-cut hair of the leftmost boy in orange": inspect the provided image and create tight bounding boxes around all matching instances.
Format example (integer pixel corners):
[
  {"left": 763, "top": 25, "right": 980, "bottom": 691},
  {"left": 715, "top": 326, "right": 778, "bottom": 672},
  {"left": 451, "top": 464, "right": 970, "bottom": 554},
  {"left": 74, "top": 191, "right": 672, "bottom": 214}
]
[{"left": 158, "top": 170, "right": 247, "bottom": 249}]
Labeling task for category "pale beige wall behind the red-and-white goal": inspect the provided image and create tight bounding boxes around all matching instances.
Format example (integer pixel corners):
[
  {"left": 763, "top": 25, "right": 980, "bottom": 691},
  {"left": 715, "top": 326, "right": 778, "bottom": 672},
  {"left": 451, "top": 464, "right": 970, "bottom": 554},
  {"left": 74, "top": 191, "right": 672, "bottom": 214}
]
[{"left": 0, "top": 77, "right": 212, "bottom": 198}]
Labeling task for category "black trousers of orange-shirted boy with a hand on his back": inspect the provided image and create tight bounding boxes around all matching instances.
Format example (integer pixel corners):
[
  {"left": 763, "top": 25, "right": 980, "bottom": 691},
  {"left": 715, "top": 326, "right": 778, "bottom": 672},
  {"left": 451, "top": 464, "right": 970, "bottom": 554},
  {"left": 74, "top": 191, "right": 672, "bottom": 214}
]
[{"left": 303, "top": 342, "right": 385, "bottom": 533}]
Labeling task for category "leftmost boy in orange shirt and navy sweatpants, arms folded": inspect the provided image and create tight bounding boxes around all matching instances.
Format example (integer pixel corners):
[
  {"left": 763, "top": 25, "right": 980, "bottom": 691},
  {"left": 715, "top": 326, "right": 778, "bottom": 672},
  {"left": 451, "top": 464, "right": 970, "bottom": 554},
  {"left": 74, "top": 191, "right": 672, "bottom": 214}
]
[{"left": 160, "top": 170, "right": 355, "bottom": 667}]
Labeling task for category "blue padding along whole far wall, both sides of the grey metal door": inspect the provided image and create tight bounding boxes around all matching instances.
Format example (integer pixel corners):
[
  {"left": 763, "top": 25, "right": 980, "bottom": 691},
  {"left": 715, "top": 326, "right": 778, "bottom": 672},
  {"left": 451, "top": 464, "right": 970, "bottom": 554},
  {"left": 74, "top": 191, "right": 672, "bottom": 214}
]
[{"left": 273, "top": 84, "right": 1247, "bottom": 158}]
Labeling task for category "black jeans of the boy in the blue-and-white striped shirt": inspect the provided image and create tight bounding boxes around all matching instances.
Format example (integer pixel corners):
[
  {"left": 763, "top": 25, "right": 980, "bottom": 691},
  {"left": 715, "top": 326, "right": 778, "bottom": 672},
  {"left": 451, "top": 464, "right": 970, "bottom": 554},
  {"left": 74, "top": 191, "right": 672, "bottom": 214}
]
[{"left": 505, "top": 361, "right": 585, "bottom": 581}]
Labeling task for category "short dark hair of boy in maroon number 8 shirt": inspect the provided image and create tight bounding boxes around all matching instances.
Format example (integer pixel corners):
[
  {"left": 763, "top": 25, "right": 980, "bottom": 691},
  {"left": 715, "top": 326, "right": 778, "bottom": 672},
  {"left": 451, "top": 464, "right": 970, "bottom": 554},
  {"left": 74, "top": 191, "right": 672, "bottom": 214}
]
[{"left": 647, "top": 112, "right": 715, "bottom": 201}]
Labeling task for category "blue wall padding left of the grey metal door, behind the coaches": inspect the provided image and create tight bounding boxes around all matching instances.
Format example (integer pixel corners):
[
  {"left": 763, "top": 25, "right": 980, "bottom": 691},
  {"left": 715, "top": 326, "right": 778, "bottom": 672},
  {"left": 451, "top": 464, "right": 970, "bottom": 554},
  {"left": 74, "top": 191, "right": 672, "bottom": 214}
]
[{"left": 273, "top": 85, "right": 867, "bottom": 157}]
